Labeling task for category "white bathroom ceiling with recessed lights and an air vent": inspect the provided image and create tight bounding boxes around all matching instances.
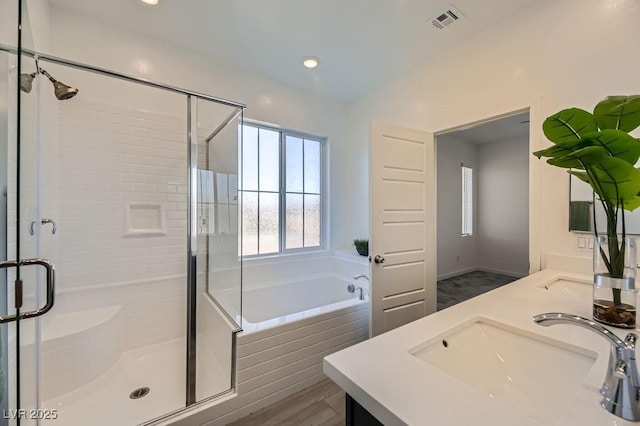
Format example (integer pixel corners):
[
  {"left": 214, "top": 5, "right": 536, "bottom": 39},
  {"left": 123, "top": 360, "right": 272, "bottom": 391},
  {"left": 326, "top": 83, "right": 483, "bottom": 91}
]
[{"left": 49, "top": 0, "right": 535, "bottom": 101}]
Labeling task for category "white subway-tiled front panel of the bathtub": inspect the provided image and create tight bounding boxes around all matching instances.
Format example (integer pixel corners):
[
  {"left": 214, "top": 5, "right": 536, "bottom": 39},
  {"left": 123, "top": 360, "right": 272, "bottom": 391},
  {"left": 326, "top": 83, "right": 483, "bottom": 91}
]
[{"left": 162, "top": 282, "right": 369, "bottom": 426}]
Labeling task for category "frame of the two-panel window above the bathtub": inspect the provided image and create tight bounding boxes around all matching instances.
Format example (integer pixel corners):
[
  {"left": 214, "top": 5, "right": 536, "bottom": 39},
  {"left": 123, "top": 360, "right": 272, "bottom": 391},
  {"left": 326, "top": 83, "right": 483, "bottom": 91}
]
[{"left": 238, "top": 118, "right": 329, "bottom": 260}]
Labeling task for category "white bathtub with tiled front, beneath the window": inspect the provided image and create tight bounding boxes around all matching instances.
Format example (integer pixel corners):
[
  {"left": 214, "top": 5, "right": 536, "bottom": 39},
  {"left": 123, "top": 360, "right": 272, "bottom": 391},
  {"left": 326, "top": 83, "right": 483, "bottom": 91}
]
[{"left": 202, "top": 272, "right": 369, "bottom": 424}]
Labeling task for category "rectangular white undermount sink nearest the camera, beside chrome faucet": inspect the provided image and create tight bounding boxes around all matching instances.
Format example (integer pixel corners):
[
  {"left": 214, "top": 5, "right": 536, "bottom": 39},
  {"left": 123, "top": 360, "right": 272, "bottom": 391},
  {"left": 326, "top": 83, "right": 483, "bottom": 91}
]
[{"left": 409, "top": 318, "right": 597, "bottom": 423}]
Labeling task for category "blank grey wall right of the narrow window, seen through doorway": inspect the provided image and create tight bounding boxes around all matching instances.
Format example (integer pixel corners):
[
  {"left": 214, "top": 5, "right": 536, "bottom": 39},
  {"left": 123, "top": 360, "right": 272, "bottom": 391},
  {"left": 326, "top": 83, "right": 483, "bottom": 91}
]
[{"left": 476, "top": 139, "right": 529, "bottom": 276}]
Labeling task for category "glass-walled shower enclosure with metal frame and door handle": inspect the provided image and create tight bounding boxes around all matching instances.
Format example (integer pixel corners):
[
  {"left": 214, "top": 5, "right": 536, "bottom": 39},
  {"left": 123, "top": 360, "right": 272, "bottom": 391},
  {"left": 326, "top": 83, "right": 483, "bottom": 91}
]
[{"left": 0, "top": 1, "right": 244, "bottom": 425}]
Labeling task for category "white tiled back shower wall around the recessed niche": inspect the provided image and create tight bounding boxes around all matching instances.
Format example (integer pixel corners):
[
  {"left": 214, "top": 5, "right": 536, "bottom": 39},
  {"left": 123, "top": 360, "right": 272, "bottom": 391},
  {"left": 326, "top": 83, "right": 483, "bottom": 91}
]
[{"left": 52, "top": 99, "right": 187, "bottom": 290}]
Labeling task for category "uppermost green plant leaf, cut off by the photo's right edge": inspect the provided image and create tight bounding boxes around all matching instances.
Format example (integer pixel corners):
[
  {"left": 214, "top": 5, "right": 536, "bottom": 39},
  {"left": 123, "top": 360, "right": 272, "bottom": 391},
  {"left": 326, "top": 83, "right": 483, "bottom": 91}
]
[{"left": 593, "top": 95, "right": 640, "bottom": 132}]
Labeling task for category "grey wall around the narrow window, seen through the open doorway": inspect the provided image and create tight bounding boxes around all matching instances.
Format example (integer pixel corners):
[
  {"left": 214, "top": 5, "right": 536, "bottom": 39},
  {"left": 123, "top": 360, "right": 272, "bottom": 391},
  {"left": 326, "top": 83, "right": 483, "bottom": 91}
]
[{"left": 436, "top": 135, "right": 478, "bottom": 279}]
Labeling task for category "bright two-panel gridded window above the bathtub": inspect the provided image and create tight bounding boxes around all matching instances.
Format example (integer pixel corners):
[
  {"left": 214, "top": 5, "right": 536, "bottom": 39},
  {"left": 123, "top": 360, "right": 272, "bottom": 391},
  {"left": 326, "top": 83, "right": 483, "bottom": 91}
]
[{"left": 240, "top": 124, "right": 323, "bottom": 256}]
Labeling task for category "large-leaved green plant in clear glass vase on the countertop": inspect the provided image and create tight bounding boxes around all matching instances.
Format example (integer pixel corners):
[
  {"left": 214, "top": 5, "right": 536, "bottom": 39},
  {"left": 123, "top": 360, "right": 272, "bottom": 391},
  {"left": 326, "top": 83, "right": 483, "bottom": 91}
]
[{"left": 534, "top": 95, "right": 640, "bottom": 328}]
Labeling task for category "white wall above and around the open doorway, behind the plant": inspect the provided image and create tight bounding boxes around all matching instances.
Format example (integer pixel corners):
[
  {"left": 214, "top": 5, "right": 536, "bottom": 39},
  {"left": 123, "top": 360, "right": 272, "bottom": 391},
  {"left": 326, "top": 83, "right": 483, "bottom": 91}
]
[{"left": 342, "top": 0, "right": 640, "bottom": 267}]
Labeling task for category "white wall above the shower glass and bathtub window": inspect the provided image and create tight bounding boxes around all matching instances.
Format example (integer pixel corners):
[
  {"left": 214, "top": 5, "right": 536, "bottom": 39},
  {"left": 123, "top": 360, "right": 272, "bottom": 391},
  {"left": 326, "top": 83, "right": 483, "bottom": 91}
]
[{"left": 51, "top": 7, "right": 348, "bottom": 253}]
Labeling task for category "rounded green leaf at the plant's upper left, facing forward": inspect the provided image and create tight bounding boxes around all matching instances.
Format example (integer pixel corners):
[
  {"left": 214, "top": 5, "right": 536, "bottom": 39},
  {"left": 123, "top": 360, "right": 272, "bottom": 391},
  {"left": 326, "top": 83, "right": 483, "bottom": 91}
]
[{"left": 542, "top": 108, "right": 598, "bottom": 144}]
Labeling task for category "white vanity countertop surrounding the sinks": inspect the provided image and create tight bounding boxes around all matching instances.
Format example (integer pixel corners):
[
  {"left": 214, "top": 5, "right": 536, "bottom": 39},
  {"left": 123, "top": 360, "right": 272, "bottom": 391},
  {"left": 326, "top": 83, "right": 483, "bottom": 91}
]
[{"left": 324, "top": 270, "right": 637, "bottom": 426}]
